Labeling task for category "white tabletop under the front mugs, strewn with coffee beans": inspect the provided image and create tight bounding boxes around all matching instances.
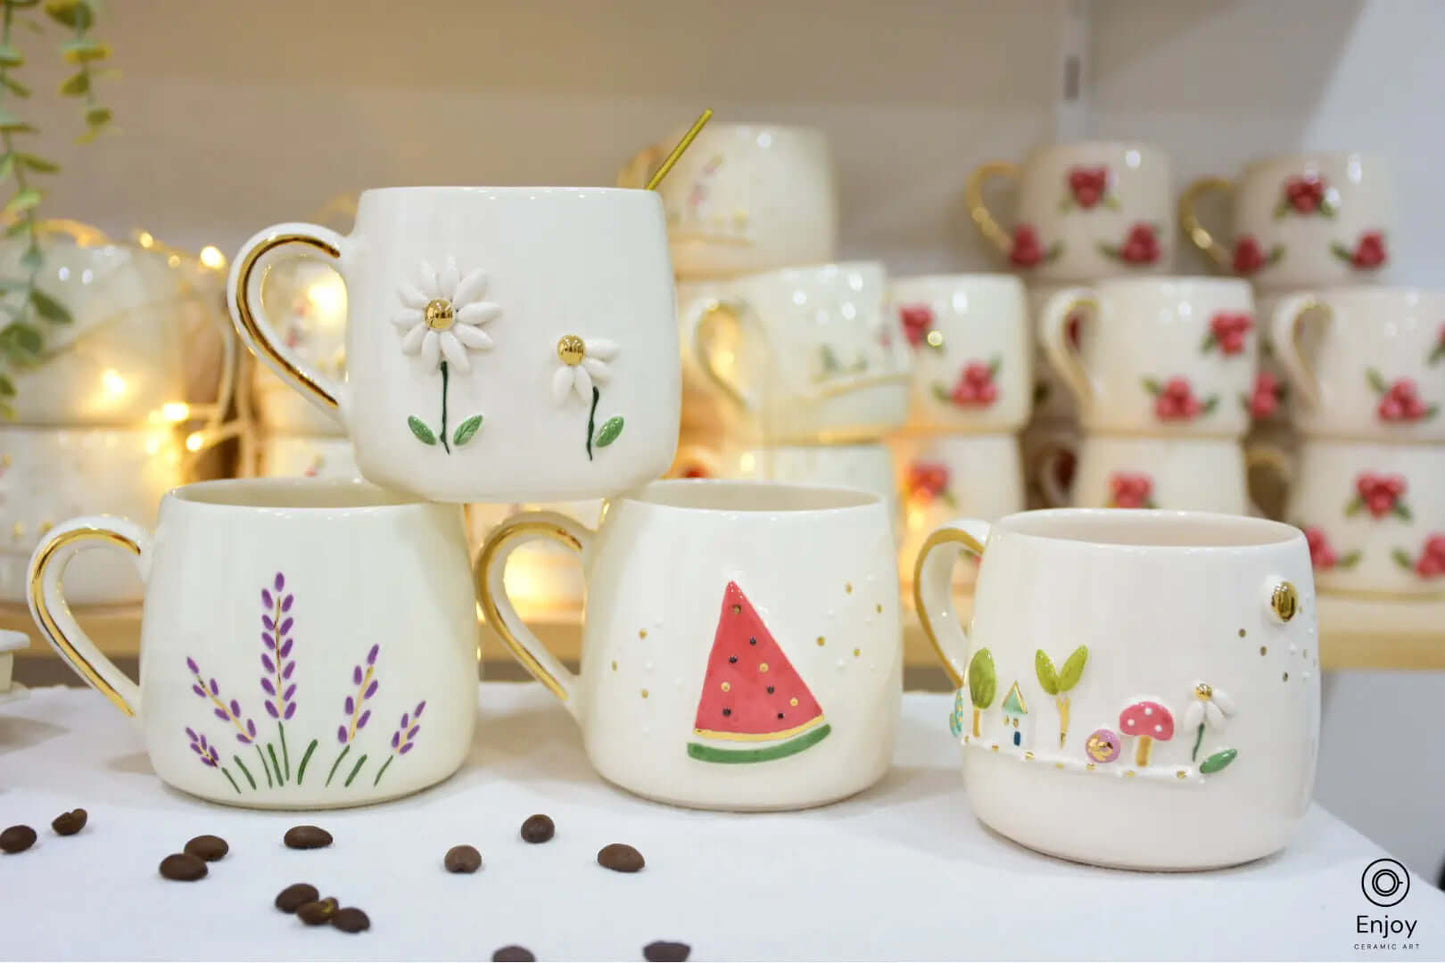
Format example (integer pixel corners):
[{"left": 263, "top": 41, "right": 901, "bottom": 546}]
[{"left": 0, "top": 684, "right": 1445, "bottom": 960}]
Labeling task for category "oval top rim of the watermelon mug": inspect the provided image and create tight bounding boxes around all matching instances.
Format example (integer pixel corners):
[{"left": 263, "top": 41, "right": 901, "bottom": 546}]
[{"left": 618, "top": 479, "right": 883, "bottom": 518}]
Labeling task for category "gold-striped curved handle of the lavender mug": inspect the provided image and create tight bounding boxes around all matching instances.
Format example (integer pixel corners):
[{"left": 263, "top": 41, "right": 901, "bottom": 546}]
[{"left": 25, "top": 515, "right": 152, "bottom": 716}]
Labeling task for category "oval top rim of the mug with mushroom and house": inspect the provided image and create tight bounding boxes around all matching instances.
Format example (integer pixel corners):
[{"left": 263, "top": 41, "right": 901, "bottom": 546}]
[{"left": 990, "top": 508, "right": 1305, "bottom": 554}]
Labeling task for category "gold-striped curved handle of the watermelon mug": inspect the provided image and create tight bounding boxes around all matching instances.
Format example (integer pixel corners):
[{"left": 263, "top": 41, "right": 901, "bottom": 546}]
[{"left": 474, "top": 512, "right": 592, "bottom": 719}]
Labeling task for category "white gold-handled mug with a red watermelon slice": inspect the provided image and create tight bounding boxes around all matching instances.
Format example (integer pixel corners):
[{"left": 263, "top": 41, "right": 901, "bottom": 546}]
[{"left": 477, "top": 480, "right": 903, "bottom": 810}]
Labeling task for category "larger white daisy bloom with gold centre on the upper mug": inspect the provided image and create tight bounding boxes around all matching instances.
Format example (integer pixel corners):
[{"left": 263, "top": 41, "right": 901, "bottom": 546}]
[{"left": 392, "top": 257, "right": 501, "bottom": 373}]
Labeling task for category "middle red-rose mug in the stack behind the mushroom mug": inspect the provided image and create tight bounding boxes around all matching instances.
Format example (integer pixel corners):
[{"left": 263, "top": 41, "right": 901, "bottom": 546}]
[{"left": 1039, "top": 271, "right": 1259, "bottom": 438}]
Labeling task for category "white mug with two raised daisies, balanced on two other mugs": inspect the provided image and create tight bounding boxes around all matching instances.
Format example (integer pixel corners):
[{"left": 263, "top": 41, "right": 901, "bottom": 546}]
[{"left": 228, "top": 188, "right": 681, "bottom": 502}]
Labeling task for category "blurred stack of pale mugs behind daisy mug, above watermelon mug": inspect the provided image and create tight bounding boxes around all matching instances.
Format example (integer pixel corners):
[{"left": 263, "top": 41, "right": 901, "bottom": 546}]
[{"left": 620, "top": 124, "right": 910, "bottom": 532}]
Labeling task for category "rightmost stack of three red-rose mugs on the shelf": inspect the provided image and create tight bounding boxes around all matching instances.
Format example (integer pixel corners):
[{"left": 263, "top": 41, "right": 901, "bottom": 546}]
[{"left": 1181, "top": 152, "right": 1445, "bottom": 597}]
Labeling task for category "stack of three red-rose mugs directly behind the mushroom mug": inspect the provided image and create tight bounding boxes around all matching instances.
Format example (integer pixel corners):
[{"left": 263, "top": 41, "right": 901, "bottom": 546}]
[{"left": 968, "top": 142, "right": 1257, "bottom": 515}]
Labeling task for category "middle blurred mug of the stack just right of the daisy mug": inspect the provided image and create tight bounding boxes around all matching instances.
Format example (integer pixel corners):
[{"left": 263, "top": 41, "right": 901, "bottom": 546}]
[{"left": 678, "top": 262, "right": 912, "bottom": 444}]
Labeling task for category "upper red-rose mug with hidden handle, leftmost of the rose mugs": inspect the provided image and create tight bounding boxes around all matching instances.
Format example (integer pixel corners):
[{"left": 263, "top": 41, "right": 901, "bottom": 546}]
[{"left": 889, "top": 275, "right": 1033, "bottom": 432}]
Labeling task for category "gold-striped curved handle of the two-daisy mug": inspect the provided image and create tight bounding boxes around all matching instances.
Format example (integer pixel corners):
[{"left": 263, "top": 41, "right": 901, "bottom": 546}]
[{"left": 225, "top": 224, "right": 347, "bottom": 419}]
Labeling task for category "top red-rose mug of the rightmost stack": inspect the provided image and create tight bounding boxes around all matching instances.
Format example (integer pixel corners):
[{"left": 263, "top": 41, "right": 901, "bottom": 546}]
[{"left": 1179, "top": 153, "right": 1396, "bottom": 289}]
